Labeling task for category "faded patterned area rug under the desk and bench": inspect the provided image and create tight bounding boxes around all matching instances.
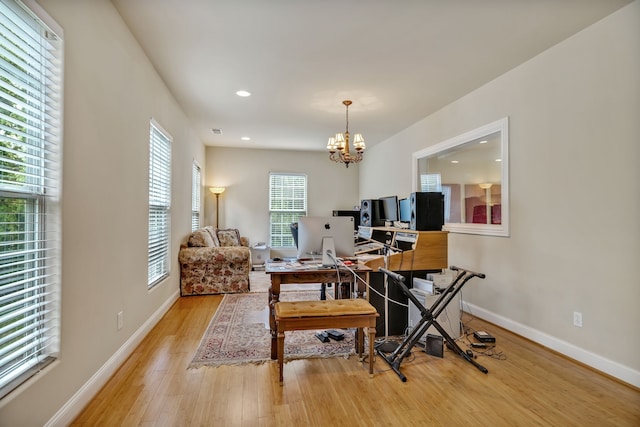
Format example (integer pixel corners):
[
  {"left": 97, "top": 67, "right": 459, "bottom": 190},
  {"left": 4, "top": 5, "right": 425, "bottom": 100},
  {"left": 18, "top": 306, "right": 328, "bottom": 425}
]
[{"left": 189, "top": 291, "right": 355, "bottom": 368}]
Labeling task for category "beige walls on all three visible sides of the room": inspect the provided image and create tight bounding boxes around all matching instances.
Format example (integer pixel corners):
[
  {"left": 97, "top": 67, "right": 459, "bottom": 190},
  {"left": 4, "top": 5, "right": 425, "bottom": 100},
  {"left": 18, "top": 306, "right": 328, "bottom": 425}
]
[{"left": 0, "top": 0, "right": 640, "bottom": 426}]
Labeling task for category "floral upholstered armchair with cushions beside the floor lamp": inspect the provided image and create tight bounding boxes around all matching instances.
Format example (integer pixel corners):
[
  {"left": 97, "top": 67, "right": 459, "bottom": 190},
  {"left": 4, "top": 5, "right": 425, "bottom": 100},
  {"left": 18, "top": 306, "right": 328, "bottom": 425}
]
[{"left": 178, "top": 227, "right": 251, "bottom": 296}]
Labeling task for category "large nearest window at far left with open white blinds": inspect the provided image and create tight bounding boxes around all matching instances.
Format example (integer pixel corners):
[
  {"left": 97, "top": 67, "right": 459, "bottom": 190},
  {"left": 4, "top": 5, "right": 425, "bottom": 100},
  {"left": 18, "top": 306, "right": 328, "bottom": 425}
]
[{"left": 0, "top": 0, "right": 63, "bottom": 398}]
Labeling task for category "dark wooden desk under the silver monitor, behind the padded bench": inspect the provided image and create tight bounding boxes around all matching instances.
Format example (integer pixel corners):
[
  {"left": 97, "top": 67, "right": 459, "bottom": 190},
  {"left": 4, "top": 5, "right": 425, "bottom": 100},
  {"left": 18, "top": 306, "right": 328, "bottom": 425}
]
[{"left": 265, "top": 262, "right": 371, "bottom": 360}]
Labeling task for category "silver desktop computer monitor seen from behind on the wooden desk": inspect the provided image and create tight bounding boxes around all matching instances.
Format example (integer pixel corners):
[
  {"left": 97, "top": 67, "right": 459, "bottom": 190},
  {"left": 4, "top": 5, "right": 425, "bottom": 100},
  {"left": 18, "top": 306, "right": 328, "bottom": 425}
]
[{"left": 298, "top": 216, "right": 355, "bottom": 259}]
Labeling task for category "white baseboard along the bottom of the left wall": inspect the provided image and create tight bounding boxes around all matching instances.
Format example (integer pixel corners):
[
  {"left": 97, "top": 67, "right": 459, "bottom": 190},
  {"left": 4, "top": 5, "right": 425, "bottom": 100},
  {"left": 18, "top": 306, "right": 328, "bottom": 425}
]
[{"left": 45, "top": 290, "right": 180, "bottom": 427}]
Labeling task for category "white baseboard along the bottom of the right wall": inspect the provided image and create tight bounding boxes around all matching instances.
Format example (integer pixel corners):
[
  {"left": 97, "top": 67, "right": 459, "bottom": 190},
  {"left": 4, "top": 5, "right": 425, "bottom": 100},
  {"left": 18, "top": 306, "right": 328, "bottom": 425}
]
[{"left": 463, "top": 301, "right": 640, "bottom": 387}]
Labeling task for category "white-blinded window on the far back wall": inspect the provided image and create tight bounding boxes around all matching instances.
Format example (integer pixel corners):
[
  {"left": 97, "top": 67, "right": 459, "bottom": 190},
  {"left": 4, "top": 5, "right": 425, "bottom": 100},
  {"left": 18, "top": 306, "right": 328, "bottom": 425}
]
[{"left": 269, "top": 173, "right": 307, "bottom": 248}]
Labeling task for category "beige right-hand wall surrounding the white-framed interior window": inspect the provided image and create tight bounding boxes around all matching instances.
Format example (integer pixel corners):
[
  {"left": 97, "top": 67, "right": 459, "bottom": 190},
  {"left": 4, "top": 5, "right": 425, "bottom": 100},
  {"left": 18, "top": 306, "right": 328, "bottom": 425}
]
[{"left": 360, "top": 1, "right": 640, "bottom": 386}]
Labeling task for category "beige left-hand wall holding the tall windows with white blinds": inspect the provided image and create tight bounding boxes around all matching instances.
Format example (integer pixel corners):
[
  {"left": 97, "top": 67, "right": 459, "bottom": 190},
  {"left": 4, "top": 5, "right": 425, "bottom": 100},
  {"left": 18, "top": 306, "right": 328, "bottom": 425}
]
[{"left": 0, "top": 0, "right": 204, "bottom": 426}]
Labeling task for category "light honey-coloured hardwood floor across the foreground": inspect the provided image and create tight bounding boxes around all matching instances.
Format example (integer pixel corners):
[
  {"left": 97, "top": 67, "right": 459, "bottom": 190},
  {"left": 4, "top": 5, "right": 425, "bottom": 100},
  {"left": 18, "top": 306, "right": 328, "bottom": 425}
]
[{"left": 72, "top": 290, "right": 640, "bottom": 427}]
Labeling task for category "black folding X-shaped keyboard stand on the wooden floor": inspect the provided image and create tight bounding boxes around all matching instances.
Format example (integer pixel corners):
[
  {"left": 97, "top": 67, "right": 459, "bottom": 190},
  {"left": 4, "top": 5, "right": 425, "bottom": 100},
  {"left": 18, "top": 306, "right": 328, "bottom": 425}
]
[{"left": 377, "top": 266, "right": 489, "bottom": 382}]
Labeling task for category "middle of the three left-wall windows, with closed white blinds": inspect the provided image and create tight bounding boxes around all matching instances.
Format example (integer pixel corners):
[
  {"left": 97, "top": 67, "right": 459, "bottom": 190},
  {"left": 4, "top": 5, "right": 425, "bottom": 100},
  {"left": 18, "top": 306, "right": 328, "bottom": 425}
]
[{"left": 148, "top": 119, "right": 171, "bottom": 288}]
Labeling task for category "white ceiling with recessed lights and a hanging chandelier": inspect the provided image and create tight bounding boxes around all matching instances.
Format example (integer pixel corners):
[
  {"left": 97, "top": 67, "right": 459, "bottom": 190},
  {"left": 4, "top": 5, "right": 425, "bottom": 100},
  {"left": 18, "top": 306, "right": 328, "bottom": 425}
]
[{"left": 112, "top": 0, "right": 630, "bottom": 150}]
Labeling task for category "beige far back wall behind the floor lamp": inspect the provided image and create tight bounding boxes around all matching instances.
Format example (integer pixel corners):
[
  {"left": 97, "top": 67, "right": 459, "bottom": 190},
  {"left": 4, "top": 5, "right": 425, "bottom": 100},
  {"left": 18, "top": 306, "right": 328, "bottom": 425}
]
[{"left": 204, "top": 147, "right": 360, "bottom": 256}]
